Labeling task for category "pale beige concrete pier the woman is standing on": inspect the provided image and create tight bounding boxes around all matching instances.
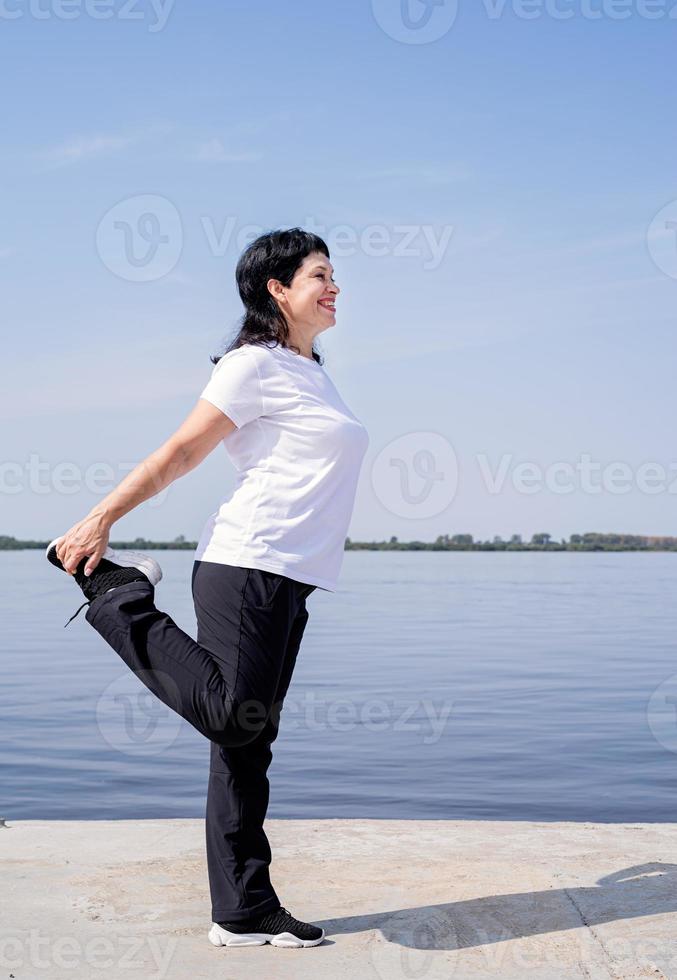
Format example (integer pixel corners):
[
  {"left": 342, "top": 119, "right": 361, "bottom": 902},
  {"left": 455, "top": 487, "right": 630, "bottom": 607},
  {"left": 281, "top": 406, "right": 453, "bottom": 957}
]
[{"left": 0, "top": 819, "right": 677, "bottom": 980}]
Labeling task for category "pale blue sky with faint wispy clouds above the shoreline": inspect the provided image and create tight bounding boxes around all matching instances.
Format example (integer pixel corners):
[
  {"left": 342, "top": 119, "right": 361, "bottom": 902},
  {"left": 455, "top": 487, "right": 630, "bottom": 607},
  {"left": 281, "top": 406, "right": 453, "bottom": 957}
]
[{"left": 0, "top": 0, "right": 677, "bottom": 540}]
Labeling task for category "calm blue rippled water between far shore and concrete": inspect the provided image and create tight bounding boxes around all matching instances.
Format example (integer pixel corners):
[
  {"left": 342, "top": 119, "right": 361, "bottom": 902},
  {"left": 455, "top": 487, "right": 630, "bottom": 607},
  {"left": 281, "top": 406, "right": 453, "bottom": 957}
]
[{"left": 0, "top": 551, "right": 677, "bottom": 821}]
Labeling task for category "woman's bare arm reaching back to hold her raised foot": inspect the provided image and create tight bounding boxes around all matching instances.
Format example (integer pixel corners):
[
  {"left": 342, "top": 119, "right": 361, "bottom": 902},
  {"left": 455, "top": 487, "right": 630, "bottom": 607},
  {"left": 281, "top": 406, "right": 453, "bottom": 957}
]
[{"left": 56, "top": 398, "right": 236, "bottom": 575}]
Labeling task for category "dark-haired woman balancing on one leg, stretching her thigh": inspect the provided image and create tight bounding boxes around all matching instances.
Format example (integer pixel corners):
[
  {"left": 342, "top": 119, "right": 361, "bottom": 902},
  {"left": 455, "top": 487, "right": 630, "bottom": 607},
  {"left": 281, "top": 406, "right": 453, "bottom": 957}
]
[{"left": 47, "top": 228, "right": 369, "bottom": 946}]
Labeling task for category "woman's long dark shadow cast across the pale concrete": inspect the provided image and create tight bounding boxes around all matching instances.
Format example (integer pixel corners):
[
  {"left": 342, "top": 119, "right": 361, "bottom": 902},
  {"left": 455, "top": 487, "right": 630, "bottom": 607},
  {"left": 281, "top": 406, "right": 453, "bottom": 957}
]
[{"left": 316, "top": 862, "right": 677, "bottom": 950}]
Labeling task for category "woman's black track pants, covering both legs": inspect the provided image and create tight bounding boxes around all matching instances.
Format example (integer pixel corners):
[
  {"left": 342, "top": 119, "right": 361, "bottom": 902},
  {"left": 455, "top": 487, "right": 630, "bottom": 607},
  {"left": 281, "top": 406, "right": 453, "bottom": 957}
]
[{"left": 86, "top": 561, "right": 315, "bottom": 922}]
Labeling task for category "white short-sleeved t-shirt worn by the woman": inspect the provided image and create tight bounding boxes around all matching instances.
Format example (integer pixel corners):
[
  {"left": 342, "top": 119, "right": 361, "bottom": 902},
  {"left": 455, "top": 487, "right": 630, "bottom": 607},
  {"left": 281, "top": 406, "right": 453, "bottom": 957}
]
[{"left": 195, "top": 342, "right": 369, "bottom": 592}]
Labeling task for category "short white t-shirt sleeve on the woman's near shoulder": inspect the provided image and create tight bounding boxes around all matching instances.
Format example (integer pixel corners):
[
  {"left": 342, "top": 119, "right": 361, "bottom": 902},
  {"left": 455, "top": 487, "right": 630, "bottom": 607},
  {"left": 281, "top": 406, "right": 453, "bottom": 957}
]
[{"left": 200, "top": 345, "right": 263, "bottom": 429}]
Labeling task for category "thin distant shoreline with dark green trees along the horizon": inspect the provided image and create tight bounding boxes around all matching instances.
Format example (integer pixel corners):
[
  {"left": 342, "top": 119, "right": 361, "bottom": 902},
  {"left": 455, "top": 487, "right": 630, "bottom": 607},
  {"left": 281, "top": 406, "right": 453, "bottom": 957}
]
[{"left": 0, "top": 532, "right": 677, "bottom": 551}]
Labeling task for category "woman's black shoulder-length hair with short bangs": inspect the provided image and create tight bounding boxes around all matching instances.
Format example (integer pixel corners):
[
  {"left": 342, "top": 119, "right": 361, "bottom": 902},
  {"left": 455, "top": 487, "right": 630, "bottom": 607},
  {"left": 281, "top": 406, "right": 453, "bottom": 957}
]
[{"left": 210, "top": 228, "right": 329, "bottom": 364}]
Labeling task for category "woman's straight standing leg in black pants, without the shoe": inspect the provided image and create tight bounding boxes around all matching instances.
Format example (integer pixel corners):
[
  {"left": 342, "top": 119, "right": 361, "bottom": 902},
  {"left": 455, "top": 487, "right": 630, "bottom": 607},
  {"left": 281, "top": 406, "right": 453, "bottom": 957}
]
[{"left": 198, "top": 581, "right": 314, "bottom": 922}]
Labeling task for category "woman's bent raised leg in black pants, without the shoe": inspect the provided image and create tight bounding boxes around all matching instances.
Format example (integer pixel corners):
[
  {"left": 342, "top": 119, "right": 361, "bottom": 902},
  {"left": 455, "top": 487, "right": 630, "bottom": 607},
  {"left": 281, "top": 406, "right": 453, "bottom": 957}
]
[{"left": 86, "top": 561, "right": 298, "bottom": 747}]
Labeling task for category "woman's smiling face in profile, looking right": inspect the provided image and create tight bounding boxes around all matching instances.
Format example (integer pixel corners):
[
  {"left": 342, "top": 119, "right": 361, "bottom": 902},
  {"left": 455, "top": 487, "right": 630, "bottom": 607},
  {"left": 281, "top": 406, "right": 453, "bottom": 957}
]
[{"left": 268, "top": 252, "right": 341, "bottom": 343}]
